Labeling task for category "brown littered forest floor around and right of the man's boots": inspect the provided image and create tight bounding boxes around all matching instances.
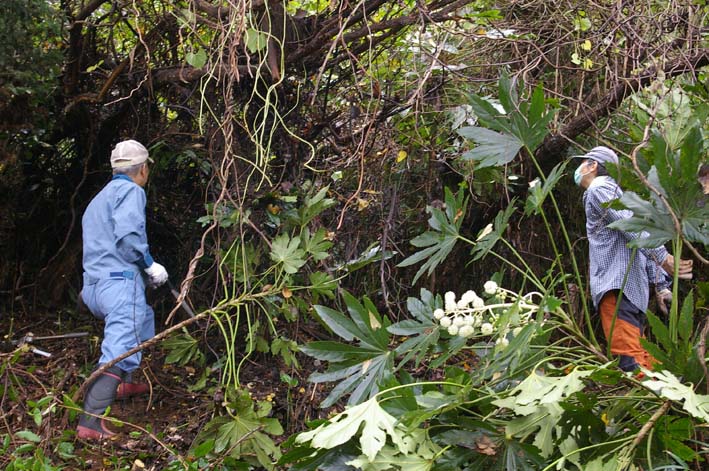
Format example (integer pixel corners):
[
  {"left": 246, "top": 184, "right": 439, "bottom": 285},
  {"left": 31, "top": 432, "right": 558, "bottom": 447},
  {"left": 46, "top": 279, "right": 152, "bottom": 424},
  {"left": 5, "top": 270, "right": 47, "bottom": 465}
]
[{"left": 0, "top": 313, "right": 327, "bottom": 469}]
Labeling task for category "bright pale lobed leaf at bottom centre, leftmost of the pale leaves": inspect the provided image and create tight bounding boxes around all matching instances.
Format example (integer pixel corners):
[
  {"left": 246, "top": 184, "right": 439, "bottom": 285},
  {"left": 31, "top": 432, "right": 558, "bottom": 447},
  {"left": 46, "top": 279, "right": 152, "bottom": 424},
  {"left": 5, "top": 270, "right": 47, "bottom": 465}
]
[{"left": 296, "top": 398, "right": 406, "bottom": 462}]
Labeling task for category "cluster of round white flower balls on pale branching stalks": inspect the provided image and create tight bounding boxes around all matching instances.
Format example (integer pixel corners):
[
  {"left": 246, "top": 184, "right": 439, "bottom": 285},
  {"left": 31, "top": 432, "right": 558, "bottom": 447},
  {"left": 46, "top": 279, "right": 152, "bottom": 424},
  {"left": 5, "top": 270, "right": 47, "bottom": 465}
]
[{"left": 433, "top": 280, "right": 541, "bottom": 348}]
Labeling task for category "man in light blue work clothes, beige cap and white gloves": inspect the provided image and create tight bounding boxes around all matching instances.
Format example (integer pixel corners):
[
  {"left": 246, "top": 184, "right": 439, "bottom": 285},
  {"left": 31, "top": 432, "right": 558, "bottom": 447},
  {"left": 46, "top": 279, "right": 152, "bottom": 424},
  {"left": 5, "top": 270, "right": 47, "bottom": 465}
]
[{"left": 77, "top": 140, "right": 168, "bottom": 440}]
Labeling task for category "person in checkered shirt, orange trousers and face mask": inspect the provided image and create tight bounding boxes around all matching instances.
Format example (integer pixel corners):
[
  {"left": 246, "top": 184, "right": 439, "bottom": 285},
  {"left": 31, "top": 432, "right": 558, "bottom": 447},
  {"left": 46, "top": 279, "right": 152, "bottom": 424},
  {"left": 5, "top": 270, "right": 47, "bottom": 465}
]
[{"left": 574, "top": 146, "right": 692, "bottom": 371}]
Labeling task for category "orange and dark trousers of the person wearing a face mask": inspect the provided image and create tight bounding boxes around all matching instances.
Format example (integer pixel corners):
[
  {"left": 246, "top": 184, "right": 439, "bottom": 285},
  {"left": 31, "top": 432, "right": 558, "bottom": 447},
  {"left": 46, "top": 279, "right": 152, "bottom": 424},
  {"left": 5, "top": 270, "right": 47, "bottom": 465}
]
[{"left": 598, "top": 291, "right": 657, "bottom": 371}]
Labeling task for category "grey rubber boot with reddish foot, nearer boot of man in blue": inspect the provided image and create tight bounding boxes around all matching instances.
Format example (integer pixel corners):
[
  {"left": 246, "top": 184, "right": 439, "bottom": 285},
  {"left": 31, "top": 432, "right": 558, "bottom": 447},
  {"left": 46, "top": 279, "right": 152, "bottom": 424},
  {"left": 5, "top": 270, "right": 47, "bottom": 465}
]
[{"left": 76, "top": 366, "right": 123, "bottom": 440}]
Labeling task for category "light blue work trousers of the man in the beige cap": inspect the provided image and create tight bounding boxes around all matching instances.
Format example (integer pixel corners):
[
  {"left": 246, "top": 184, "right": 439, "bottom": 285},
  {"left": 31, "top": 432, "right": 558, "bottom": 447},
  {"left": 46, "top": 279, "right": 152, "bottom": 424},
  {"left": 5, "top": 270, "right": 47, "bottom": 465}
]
[{"left": 81, "top": 274, "right": 155, "bottom": 372}]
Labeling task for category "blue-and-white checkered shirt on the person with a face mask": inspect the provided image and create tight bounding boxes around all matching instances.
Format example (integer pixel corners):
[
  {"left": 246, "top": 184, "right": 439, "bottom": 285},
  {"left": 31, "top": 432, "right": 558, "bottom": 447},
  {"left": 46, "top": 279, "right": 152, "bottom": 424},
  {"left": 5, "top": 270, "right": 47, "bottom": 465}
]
[{"left": 583, "top": 176, "right": 669, "bottom": 312}]
